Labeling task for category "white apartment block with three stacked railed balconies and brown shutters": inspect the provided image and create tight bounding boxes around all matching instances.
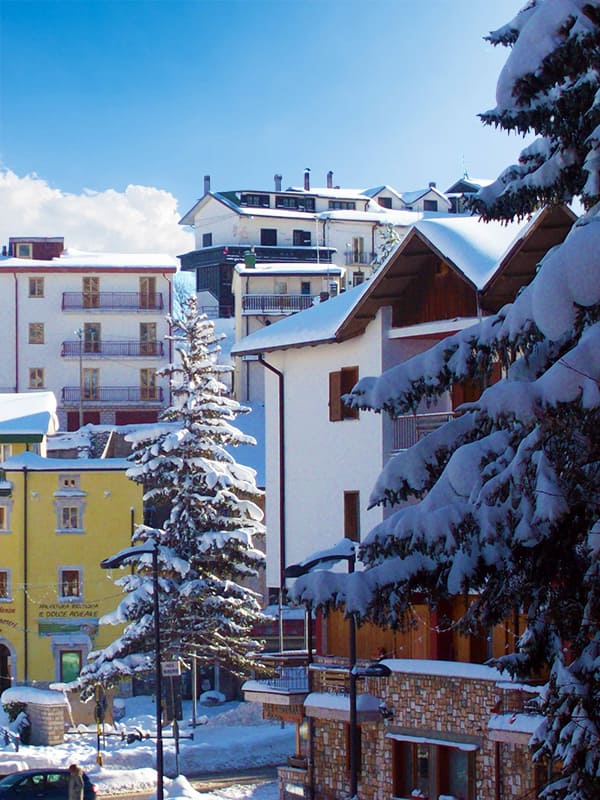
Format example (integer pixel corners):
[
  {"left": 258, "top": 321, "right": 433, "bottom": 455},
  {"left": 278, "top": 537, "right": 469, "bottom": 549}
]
[{"left": 0, "top": 239, "right": 177, "bottom": 430}]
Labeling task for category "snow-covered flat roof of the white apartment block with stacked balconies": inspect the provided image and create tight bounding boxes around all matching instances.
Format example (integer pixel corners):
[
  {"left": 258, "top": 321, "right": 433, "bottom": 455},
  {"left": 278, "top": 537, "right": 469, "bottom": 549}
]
[{"left": 0, "top": 248, "right": 178, "bottom": 272}]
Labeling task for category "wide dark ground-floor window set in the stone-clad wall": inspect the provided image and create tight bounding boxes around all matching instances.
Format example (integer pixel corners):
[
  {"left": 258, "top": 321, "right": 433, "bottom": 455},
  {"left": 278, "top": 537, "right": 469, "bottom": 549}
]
[{"left": 392, "top": 740, "right": 474, "bottom": 800}]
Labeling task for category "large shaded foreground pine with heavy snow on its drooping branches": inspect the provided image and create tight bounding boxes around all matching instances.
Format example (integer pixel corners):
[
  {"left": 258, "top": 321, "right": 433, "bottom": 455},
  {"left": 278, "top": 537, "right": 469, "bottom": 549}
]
[{"left": 295, "top": 0, "right": 600, "bottom": 800}]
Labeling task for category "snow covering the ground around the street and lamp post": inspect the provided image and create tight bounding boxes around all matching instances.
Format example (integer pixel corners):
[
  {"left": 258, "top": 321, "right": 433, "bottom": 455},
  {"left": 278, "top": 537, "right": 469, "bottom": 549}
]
[{"left": 0, "top": 696, "right": 295, "bottom": 800}]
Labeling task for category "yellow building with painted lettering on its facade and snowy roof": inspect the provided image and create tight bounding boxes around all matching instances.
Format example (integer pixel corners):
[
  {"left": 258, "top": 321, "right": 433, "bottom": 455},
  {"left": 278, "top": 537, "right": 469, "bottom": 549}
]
[{"left": 0, "top": 393, "right": 143, "bottom": 691}]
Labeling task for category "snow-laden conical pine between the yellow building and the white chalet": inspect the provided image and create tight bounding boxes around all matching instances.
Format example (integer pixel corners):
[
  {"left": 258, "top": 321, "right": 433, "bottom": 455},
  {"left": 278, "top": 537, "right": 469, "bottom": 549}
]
[{"left": 80, "top": 296, "right": 264, "bottom": 694}]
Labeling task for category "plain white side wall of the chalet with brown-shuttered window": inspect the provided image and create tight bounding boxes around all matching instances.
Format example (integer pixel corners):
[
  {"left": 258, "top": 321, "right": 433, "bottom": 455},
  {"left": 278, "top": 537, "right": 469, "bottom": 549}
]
[{"left": 265, "top": 317, "right": 382, "bottom": 586}]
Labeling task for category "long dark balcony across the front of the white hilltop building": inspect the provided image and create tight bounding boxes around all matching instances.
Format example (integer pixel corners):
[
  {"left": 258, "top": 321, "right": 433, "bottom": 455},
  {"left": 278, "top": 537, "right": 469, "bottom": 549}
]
[{"left": 181, "top": 244, "right": 336, "bottom": 271}]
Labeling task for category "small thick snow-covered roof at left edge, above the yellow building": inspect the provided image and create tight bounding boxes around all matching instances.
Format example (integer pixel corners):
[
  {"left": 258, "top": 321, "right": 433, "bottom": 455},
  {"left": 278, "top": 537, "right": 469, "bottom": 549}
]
[{"left": 0, "top": 392, "right": 58, "bottom": 441}]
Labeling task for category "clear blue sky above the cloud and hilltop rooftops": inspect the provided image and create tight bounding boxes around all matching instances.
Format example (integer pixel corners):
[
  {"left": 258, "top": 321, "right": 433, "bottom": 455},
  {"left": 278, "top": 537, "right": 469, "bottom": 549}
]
[{"left": 0, "top": 0, "right": 523, "bottom": 253}]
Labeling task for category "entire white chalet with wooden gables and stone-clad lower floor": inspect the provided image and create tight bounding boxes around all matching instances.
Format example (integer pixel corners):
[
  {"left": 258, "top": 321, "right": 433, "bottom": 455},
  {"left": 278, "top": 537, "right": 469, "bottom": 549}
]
[{"left": 233, "top": 208, "right": 574, "bottom": 800}]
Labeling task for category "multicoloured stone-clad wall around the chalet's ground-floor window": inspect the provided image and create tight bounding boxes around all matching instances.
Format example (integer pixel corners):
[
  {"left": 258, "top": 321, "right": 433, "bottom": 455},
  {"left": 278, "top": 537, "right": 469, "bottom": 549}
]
[{"left": 304, "top": 671, "right": 535, "bottom": 800}]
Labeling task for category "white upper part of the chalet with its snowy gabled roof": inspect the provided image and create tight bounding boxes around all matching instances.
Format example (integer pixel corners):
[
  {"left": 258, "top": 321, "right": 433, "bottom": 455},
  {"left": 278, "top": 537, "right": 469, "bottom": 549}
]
[{"left": 232, "top": 209, "right": 573, "bottom": 590}]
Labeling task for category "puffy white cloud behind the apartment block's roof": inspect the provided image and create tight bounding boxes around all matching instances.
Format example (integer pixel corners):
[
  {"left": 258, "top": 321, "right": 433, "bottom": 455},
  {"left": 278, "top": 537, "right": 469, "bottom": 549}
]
[{"left": 0, "top": 169, "right": 194, "bottom": 256}]
